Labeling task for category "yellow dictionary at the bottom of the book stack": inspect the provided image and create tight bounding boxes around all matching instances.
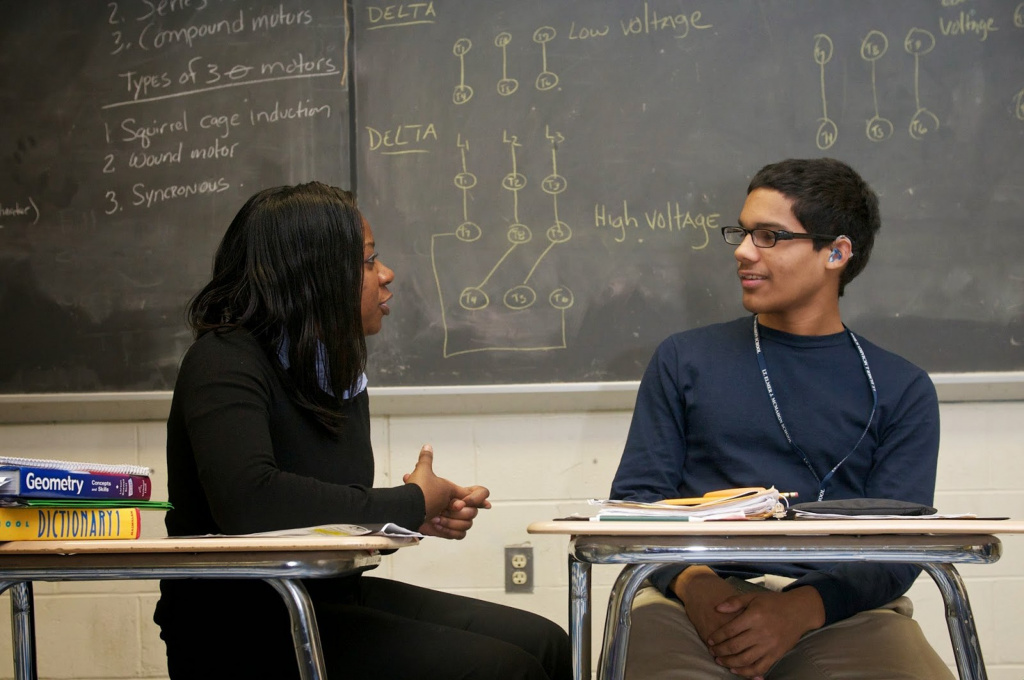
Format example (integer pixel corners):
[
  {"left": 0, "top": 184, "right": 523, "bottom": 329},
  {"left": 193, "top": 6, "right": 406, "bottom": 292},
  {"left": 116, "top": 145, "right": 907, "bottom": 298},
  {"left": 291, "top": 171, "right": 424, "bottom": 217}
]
[{"left": 0, "top": 508, "right": 140, "bottom": 541}]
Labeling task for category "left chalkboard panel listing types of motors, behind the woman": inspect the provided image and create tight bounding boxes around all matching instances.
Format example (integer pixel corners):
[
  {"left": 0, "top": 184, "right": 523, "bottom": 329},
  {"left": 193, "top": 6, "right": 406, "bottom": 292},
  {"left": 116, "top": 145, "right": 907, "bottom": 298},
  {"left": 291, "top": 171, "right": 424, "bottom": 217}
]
[{"left": 0, "top": 0, "right": 351, "bottom": 393}]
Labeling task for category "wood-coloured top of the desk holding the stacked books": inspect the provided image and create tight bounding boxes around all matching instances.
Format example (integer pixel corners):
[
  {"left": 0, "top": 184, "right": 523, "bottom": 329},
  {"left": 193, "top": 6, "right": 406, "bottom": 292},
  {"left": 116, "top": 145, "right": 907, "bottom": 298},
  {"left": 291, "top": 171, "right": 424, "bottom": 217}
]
[{"left": 0, "top": 536, "right": 419, "bottom": 559}]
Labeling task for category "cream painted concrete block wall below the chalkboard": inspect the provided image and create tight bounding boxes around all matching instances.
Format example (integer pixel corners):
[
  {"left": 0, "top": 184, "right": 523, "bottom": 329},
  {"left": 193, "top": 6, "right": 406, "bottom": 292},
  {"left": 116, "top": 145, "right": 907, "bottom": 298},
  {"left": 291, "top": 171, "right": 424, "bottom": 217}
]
[{"left": 0, "top": 401, "right": 1024, "bottom": 680}]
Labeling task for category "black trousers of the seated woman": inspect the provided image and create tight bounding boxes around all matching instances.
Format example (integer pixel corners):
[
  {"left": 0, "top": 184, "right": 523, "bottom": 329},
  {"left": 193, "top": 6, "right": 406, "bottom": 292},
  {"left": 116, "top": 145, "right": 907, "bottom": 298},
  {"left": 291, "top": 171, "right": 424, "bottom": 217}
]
[{"left": 155, "top": 577, "right": 572, "bottom": 680}]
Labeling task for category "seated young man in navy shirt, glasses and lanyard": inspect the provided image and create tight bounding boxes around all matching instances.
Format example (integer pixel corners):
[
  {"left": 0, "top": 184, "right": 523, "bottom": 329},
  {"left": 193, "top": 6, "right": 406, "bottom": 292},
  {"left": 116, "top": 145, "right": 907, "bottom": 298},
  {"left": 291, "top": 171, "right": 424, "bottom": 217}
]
[{"left": 611, "top": 159, "right": 952, "bottom": 680}]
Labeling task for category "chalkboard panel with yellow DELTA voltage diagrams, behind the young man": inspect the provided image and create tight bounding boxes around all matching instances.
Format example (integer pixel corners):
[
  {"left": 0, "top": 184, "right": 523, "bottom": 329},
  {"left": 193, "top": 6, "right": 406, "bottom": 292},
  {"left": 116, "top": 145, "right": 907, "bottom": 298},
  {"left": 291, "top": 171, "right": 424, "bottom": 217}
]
[{"left": 353, "top": 0, "right": 1024, "bottom": 385}]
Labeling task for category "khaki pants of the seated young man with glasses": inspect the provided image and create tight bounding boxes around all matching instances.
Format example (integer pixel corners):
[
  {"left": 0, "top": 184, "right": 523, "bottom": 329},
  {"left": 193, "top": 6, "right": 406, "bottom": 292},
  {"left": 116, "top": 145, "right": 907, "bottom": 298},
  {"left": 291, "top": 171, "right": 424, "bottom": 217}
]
[{"left": 626, "top": 584, "right": 953, "bottom": 680}]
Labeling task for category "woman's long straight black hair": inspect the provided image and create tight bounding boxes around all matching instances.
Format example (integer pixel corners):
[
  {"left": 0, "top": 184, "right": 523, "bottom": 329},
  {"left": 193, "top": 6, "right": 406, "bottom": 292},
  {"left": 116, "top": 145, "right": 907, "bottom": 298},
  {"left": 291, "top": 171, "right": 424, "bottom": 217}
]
[{"left": 187, "top": 182, "right": 367, "bottom": 431}]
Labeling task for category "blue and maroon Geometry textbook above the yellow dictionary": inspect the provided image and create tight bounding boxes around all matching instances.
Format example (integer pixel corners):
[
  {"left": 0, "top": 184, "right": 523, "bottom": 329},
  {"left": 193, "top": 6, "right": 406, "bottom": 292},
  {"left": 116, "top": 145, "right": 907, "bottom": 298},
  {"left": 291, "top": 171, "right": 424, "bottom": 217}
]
[{"left": 0, "top": 465, "right": 153, "bottom": 501}]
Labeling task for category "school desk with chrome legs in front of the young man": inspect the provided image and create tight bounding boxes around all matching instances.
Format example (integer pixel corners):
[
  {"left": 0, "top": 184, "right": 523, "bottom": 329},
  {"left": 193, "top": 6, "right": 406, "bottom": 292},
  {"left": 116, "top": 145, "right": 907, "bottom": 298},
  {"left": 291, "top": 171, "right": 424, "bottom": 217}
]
[{"left": 527, "top": 519, "right": 1024, "bottom": 680}]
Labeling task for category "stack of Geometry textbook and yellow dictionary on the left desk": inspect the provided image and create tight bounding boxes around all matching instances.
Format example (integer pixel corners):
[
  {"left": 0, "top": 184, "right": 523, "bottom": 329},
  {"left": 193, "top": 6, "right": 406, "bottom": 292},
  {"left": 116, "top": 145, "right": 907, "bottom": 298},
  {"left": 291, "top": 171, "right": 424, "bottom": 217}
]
[{"left": 0, "top": 457, "right": 170, "bottom": 541}]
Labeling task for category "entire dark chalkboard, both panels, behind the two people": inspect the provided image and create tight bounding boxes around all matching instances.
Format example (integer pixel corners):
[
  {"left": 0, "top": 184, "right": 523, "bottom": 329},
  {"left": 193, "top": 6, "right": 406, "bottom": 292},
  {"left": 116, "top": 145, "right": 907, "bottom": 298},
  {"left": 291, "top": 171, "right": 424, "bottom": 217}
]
[{"left": 0, "top": 0, "right": 1024, "bottom": 393}]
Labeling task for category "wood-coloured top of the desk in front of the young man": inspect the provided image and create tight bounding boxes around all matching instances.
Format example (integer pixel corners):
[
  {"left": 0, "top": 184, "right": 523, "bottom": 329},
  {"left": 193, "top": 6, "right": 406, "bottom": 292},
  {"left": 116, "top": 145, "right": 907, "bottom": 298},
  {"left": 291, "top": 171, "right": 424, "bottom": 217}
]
[{"left": 526, "top": 519, "right": 1024, "bottom": 537}]
